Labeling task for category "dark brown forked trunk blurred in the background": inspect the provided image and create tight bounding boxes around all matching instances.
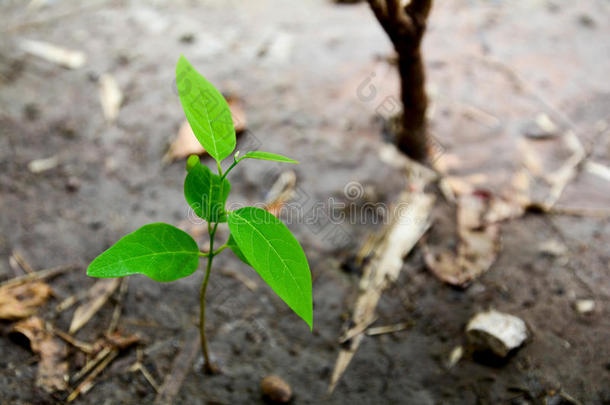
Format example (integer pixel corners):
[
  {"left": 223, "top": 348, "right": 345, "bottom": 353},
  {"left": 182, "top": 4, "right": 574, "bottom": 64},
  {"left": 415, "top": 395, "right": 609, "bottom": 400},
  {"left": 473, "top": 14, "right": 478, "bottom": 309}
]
[{"left": 368, "top": 0, "right": 432, "bottom": 161}]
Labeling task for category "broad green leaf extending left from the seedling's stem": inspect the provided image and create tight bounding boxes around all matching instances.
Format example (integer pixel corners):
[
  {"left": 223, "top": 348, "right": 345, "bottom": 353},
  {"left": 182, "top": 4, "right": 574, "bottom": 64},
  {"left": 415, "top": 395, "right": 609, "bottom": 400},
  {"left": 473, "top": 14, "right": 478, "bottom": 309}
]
[{"left": 87, "top": 223, "right": 199, "bottom": 281}]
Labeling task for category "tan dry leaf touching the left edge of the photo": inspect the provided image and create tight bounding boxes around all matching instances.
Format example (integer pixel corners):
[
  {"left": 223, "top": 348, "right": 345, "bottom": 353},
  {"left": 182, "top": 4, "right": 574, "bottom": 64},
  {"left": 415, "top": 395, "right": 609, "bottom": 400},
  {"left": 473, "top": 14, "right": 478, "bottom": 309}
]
[{"left": 0, "top": 281, "right": 52, "bottom": 320}]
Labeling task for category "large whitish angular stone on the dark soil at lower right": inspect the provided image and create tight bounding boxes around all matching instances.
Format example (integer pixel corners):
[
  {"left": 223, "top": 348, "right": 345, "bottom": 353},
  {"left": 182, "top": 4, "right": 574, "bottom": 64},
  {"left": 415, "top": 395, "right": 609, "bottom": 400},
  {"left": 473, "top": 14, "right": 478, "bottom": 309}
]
[{"left": 466, "top": 310, "right": 527, "bottom": 357}]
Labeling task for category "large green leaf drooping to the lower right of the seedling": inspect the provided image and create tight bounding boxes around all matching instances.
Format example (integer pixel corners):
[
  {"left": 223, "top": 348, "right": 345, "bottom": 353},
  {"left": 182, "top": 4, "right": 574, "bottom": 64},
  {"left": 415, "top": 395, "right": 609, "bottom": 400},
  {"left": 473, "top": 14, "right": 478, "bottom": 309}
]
[{"left": 227, "top": 207, "right": 313, "bottom": 328}]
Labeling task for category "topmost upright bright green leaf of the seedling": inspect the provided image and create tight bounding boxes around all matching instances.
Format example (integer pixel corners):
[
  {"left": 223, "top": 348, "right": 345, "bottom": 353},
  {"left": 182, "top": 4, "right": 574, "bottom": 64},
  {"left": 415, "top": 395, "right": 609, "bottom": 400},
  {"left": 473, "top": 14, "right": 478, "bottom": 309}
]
[{"left": 176, "top": 56, "right": 235, "bottom": 162}]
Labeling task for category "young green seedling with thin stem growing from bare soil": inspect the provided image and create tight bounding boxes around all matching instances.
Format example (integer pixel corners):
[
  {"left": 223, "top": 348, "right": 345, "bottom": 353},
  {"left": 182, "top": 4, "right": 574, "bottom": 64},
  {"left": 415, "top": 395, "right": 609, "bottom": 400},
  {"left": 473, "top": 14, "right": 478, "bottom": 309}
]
[{"left": 87, "top": 56, "right": 313, "bottom": 372}]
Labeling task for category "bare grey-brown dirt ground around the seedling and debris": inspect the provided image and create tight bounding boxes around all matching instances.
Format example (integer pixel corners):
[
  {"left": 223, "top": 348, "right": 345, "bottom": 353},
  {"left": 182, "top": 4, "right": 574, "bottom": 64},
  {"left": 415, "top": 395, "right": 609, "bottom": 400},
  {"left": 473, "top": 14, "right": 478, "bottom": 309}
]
[{"left": 0, "top": 0, "right": 610, "bottom": 405}]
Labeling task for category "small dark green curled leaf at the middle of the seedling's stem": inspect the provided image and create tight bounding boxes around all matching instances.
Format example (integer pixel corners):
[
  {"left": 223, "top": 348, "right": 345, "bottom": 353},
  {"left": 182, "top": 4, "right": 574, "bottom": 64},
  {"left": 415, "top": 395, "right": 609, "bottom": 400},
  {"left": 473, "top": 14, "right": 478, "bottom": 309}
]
[{"left": 184, "top": 164, "right": 231, "bottom": 222}]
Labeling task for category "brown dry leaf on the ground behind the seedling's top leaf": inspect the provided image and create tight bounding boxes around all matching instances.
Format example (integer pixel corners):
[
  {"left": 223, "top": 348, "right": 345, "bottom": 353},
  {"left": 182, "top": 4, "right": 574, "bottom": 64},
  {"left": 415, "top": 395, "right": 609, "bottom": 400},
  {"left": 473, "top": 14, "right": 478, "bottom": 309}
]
[{"left": 163, "top": 96, "right": 246, "bottom": 163}]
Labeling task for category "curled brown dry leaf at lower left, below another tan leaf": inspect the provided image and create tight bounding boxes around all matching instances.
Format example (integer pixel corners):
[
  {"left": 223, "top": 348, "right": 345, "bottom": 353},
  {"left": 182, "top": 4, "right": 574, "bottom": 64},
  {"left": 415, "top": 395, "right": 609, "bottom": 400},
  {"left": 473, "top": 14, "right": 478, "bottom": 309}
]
[{"left": 11, "top": 317, "right": 68, "bottom": 393}]
